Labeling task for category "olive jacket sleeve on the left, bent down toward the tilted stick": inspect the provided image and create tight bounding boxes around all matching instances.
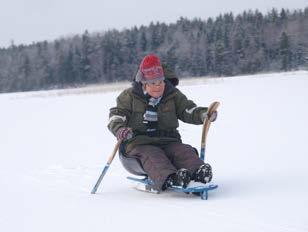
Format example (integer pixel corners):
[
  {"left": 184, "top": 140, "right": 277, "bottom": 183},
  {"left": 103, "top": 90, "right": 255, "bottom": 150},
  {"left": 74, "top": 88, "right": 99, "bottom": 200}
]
[{"left": 108, "top": 90, "right": 132, "bottom": 135}]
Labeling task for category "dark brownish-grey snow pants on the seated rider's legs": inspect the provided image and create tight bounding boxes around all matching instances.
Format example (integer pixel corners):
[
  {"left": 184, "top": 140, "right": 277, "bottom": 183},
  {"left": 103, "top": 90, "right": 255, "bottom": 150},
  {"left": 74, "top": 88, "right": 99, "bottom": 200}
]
[{"left": 127, "top": 143, "right": 204, "bottom": 190}]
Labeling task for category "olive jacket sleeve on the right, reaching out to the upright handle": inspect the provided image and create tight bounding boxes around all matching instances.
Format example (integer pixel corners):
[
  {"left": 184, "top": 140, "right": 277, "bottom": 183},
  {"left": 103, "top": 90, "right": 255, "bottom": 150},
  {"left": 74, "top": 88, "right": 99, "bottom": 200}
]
[{"left": 175, "top": 89, "right": 208, "bottom": 125}]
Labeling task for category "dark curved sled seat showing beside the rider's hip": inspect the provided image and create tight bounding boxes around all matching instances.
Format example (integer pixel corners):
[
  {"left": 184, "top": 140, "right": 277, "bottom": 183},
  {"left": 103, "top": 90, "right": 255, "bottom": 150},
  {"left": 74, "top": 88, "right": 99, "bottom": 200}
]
[{"left": 119, "top": 144, "right": 147, "bottom": 176}]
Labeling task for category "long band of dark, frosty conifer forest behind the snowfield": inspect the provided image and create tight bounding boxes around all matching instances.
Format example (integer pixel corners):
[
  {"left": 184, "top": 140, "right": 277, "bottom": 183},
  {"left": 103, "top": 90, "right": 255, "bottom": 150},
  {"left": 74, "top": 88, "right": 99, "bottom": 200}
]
[{"left": 0, "top": 7, "right": 308, "bottom": 92}]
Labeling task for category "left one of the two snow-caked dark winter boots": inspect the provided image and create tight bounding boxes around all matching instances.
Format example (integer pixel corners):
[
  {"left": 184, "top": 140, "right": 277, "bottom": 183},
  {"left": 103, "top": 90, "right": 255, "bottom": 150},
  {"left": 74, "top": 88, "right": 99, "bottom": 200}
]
[{"left": 163, "top": 168, "right": 192, "bottom": 190}]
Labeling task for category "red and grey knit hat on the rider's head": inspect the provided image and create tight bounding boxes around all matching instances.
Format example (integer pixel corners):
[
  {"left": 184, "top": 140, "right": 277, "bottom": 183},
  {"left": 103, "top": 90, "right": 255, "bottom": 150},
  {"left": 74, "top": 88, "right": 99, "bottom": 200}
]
[{"left": 139, "top": 54, "right": 165, "bottom": 83}]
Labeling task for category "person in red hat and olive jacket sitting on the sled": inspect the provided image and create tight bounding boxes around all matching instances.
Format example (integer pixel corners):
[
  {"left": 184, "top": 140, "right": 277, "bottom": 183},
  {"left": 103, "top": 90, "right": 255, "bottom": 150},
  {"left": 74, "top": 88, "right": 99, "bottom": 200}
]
[{"left": 108, "top": 54, "right": 217, "bottom": 191}]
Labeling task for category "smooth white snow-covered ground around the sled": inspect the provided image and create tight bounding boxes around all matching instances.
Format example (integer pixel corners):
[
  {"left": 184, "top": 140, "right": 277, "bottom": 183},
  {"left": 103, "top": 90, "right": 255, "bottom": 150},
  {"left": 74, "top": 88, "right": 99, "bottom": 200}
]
[{"left": 0, "top": 71, "right": 308, "bottom": 232}]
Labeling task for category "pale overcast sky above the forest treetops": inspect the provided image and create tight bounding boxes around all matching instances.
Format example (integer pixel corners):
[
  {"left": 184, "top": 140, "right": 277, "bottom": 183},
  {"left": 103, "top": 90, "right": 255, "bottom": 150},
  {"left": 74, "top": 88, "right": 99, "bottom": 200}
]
[{"left": 0, "top": 0, "right": 308, "bottom": 47}]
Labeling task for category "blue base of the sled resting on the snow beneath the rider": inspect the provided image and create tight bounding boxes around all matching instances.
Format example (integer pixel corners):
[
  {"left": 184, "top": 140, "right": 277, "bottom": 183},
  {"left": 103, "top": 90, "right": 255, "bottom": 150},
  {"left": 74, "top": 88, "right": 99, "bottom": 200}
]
[{"left": 127, "top": 176, "right": 218, "bottom": 200}]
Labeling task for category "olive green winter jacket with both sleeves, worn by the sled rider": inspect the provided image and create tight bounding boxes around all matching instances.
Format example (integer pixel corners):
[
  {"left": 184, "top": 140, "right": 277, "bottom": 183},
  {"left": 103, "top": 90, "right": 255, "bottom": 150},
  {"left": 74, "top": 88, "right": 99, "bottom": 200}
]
[{"left": 108, "top": 81, "right": 207, "bottom": 152}]
